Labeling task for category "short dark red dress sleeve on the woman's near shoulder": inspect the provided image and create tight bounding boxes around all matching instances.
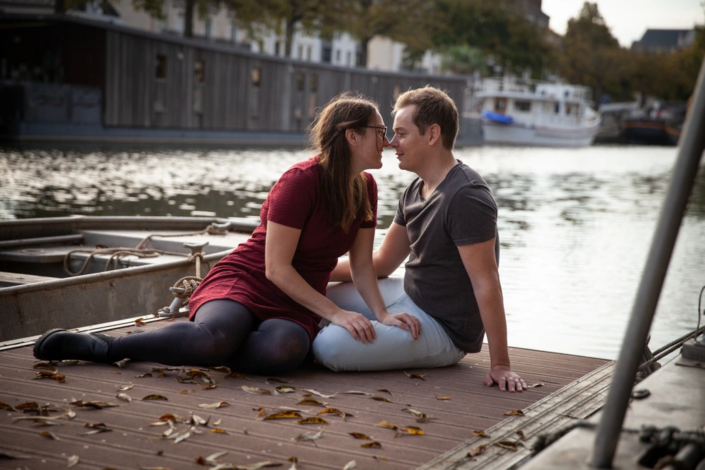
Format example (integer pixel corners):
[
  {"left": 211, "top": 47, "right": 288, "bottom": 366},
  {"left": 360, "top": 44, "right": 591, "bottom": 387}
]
[{"left": 267, "top": 168, "right": 318, "bottom": 230}]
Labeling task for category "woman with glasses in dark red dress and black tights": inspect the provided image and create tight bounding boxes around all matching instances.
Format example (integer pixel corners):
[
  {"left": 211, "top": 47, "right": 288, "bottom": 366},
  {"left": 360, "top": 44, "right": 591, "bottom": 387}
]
[{"left": 34, "top": 95, "right": 418, "bottom": 375}]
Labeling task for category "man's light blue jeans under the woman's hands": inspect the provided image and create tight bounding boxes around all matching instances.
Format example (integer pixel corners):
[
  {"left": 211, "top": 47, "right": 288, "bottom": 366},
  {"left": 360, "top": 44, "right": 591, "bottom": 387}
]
[{"left": 313, "top": 278, "right": 465, "bottom": 372}]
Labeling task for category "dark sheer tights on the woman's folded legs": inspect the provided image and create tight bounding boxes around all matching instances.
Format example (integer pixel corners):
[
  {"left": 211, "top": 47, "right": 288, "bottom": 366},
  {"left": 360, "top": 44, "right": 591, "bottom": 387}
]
[{"left": 108, "top": 300, "right": 310, "bottom": 375}]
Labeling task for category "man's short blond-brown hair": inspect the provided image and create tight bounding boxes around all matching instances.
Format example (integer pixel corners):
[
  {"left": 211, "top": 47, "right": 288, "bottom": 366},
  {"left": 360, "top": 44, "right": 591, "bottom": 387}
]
[{"left": 392, "top": 85, "right": 460, "bottom": 150}]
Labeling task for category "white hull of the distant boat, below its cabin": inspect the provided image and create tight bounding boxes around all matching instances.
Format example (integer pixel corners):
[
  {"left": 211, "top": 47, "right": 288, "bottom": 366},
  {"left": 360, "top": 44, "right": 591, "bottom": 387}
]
[{"left": 482, "top": 120, "right": 598, "bottom": 147}]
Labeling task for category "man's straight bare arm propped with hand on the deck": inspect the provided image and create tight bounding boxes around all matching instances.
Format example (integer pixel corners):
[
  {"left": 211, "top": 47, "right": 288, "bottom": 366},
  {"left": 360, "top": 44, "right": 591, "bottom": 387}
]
[{"left": 458, "top": 238, "right": 526, "bottom": 392}]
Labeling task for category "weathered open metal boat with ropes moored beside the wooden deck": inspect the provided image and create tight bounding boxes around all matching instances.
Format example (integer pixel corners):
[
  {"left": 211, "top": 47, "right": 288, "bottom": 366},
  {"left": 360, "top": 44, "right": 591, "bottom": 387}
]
[{"left": 0, "top": 217, "right": 258, "bottom": 341}]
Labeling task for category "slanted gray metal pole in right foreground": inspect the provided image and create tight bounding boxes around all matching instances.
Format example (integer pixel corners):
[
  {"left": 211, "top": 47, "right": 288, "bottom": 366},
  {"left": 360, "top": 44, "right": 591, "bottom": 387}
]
[{"left": 590, "top": 57, "right": 705, "bottom": 468}]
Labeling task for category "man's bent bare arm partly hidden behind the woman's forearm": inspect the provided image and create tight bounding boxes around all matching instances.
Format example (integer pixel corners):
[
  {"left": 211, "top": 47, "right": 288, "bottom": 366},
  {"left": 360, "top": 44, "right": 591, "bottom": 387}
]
[{"left": 330, "top": 222, "right": 411, "bottom": 282}]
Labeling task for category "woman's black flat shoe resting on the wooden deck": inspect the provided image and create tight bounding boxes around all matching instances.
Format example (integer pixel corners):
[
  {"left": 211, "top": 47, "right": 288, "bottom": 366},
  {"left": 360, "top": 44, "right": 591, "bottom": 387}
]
[{"left": 33, "top": 328, "right": 113, "bottom": 363}]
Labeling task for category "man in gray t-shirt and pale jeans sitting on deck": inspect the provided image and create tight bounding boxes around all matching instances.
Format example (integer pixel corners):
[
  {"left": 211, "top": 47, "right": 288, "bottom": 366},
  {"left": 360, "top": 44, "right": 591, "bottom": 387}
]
[{"left": 313, "top": 86, "right": 526, "bottom": 392}]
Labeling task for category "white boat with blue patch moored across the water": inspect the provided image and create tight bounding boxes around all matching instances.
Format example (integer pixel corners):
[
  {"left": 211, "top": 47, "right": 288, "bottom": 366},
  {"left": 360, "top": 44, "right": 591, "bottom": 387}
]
[{"left": 476, "top": 79, "right": 600, "bottom": 147}]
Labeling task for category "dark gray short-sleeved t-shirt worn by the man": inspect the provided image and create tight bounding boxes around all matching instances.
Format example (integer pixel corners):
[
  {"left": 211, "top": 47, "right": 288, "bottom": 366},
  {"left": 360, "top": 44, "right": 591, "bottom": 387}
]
[{"left": 394, "top": 161, "right": 499, "bottom": 353}]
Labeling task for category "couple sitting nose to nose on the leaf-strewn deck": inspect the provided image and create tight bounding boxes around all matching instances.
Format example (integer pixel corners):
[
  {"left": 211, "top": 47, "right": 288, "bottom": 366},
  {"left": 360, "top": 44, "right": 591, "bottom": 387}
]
[{"left": 34, "top": 86, "right": 526, "bottom": 392}]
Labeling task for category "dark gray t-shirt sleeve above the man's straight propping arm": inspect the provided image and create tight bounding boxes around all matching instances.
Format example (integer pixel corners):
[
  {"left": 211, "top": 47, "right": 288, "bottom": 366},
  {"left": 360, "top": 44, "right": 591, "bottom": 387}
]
[{"left": 446, "top": 187, "right": 497, "bottom": 246}]
